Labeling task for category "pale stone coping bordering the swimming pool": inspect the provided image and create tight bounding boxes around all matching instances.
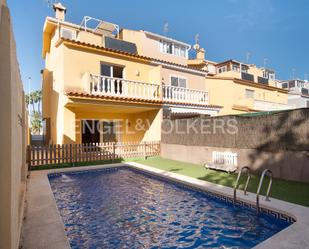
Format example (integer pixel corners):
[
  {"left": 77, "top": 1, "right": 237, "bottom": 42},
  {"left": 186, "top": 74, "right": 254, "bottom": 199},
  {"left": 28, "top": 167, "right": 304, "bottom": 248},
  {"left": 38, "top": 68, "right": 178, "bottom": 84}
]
[{"left": 21, "top": 162, "right": 309, "bottom": 249}]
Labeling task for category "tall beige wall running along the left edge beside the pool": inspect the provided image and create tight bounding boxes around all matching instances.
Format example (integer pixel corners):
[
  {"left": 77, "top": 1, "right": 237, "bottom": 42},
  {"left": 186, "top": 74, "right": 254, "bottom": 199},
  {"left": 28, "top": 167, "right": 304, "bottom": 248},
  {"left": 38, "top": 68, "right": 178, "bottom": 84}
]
[{"left": 0, "top": 0, "right": 27, "bottom": 249}]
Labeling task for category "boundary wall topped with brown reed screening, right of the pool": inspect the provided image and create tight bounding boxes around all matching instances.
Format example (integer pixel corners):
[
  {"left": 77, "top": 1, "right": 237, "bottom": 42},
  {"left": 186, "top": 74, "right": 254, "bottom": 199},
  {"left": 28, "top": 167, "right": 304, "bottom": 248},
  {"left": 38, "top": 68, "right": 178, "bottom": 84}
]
[{"left": 161, "top": 108, "right": 309, "bottom": 182}]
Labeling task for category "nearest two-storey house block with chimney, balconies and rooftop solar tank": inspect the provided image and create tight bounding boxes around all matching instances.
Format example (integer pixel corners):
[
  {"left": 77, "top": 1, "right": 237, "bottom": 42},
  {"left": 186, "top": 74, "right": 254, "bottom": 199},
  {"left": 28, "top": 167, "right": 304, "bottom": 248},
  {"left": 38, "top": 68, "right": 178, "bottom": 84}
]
[{"left": 42, "top": 4, "right": 221, "bottom": 144}]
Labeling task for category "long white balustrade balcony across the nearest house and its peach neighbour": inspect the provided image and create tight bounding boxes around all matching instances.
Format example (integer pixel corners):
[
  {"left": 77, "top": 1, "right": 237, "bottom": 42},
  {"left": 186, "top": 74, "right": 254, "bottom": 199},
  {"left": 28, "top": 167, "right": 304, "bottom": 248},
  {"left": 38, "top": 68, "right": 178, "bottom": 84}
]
[{"left": 88, "top": 74, "right": 208, "bottom": 105}]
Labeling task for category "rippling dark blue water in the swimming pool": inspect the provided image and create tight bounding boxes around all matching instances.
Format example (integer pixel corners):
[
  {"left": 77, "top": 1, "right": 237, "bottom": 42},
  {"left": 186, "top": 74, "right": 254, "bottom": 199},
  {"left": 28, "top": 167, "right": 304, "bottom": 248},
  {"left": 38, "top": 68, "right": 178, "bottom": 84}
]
[{"left": 49, "top": 168, "right": 289, "bottom": 249}]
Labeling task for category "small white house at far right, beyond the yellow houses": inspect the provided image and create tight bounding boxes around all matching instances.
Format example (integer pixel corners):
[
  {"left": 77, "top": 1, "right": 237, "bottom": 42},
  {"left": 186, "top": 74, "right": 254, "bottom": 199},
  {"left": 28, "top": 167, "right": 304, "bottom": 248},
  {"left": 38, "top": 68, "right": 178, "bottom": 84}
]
[{"left": 278, "top": 79, "right": 309, "bottom": 108}]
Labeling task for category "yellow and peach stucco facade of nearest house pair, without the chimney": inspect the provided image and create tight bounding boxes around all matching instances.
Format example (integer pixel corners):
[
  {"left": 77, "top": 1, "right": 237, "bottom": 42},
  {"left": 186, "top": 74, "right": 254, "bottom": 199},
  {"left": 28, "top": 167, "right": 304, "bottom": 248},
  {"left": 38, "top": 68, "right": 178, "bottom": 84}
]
[{"left": 42, "top": 14, "right": 220, "bottom": 144}]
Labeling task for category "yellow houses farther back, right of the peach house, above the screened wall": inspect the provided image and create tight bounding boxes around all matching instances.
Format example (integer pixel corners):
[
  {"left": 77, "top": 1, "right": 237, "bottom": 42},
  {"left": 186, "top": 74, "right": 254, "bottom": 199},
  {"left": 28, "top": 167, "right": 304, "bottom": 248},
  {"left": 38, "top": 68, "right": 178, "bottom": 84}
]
[{"left": 189, "top": 54, "right": 291, "bottom": 115}]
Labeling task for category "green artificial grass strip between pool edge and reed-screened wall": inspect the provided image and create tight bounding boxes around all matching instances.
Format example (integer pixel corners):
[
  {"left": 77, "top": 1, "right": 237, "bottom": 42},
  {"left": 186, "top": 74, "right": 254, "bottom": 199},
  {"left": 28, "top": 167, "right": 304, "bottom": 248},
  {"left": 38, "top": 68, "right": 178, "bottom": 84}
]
[{"left": 136, "top": 157, "right": 309, "bottom": 207}]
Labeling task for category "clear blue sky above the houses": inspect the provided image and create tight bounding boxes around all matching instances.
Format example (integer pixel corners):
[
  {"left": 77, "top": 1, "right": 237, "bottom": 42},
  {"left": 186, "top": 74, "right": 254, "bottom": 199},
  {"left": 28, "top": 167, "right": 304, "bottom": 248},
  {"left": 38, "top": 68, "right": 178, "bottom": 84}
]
[{"left": 7, "top": 0, "right": 309, "bottom": 92}]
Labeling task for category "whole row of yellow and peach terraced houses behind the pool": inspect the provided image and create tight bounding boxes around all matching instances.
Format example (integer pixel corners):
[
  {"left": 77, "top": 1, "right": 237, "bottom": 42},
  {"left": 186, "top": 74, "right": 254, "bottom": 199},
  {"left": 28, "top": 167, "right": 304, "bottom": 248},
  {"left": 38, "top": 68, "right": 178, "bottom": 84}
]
[{"left": 42, "top": 5, "right": 289, "bottom": 143}]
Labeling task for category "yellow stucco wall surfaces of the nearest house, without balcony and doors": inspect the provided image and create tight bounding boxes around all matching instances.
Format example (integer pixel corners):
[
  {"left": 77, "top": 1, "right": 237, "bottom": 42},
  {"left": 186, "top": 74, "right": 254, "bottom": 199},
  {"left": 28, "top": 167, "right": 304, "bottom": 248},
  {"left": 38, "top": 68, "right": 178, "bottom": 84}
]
[{"left": 43, "top": 35, "right": 162, "bottom": 144}]
